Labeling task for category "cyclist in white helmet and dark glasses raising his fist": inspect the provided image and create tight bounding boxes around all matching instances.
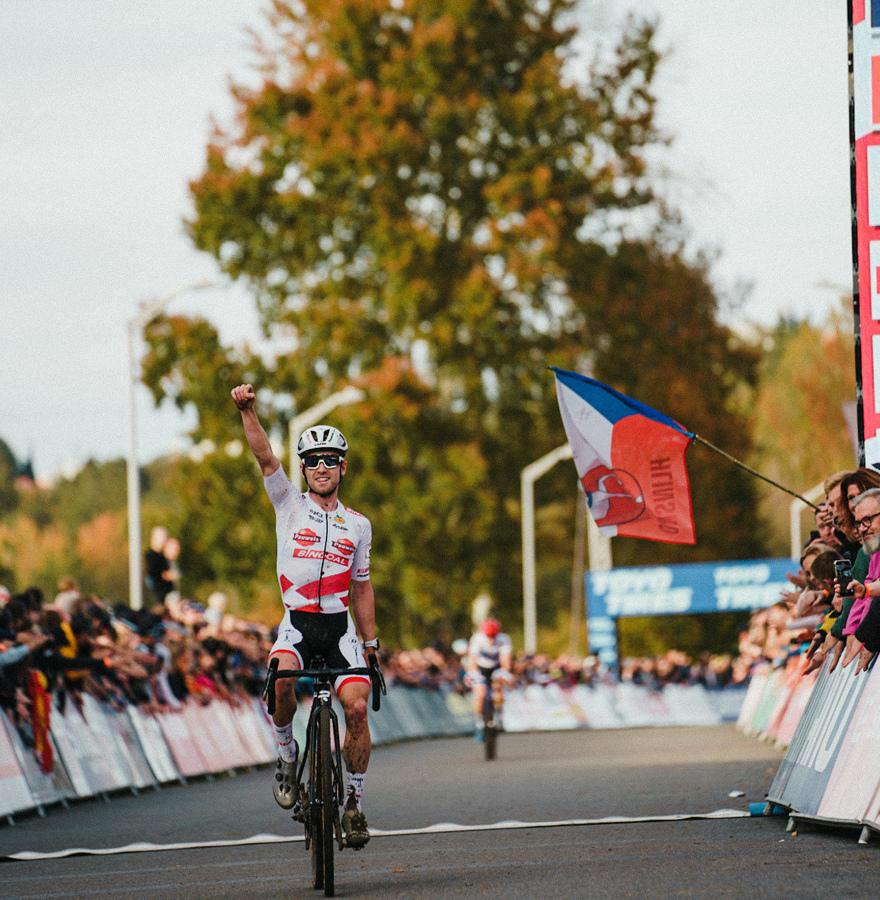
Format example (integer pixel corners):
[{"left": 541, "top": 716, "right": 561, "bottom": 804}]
[{"left": 232, "top": 384, "right": 379, "bottom": 848}]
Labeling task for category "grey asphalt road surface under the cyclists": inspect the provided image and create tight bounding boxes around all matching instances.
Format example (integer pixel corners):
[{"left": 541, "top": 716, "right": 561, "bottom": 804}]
[{"left": 0, "top": 727, "right": 880, "bottom": 900}]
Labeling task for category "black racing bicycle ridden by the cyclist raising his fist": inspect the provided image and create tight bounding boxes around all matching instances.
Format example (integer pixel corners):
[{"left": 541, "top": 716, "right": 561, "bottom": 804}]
[{"left": 263, "top": 655, "right": 386, "bottom": 897}]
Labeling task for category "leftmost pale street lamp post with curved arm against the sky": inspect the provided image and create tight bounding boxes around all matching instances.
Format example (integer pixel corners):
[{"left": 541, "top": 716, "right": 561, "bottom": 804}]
[{"left": 126, "top": 281, "right": 220, "bottom": 609}]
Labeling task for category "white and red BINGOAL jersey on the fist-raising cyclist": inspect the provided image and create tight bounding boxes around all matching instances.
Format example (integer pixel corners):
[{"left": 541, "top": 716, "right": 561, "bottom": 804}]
[{"left": 263, "top": 466, "right": 373, "bottom": 613}]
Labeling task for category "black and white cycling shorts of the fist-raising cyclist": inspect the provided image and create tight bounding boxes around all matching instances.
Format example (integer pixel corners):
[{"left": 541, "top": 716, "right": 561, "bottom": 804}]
[{"left": 269, "top": 609, "right": 370, "bottom": 693}]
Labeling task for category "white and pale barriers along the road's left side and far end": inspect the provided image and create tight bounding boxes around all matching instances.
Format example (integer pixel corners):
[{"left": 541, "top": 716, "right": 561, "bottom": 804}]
[{"left": 0, "top": 684, "right": 744, "bottom": 817}]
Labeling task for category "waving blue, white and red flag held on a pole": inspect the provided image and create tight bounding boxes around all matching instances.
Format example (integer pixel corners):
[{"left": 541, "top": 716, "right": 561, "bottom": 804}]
[{"left": 551, "top": 366, "right": 696, "bottom": 544}]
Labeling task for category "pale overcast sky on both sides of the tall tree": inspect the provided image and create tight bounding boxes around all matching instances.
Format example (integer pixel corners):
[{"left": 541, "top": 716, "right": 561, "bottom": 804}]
[{"left": 0, "top": 0, "right": 851, "bottom": 478}]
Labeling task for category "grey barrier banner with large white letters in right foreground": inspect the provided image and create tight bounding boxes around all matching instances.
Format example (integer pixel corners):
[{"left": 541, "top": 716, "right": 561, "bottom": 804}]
[{"left": 768, "top": 659, "right": 868, "bottom": 816}]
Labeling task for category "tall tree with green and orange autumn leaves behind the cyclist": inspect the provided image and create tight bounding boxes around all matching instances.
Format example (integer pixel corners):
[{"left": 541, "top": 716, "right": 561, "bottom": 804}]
[{"left": 138, "top": 0, "right": 764, "bottom": 648}]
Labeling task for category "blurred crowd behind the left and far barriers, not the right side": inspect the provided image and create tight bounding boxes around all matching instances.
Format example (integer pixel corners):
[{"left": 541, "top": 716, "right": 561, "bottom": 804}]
[{"left": 0, "top": 578, "right": 748, "bottom": 764}]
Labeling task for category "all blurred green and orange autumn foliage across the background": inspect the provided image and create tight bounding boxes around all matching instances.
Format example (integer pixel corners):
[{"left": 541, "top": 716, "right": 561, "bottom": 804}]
[{"left": 0, "top": 0, "right": 854, "bottom": 652}]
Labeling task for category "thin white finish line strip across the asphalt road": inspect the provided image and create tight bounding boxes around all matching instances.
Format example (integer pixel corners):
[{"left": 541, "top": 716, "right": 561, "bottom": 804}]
[{"left": 6, "top": 809, "right": 749, "bottom": 862}]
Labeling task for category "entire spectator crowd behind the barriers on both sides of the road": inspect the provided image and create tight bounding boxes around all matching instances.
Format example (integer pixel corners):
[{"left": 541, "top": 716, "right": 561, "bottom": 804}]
[{"left": 0, "top": 468, "right": 880, "bottom": 768}]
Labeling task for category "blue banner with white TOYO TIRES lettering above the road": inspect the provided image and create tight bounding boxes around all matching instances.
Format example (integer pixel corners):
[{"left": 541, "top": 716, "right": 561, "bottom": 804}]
[{"left": 585, "top": 559, "right": 794, "bottom": 665}]
